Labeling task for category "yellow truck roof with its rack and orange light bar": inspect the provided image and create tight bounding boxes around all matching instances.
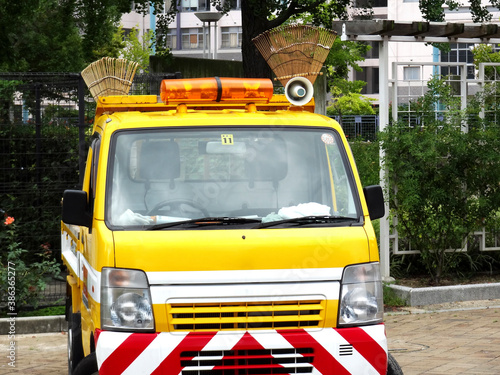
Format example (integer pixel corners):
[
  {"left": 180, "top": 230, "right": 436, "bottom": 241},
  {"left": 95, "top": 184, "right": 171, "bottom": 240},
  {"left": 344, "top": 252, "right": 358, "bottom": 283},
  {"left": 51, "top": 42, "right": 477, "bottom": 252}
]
[{"left": 94, "top": 77, "right": 335, "bottom": 137}]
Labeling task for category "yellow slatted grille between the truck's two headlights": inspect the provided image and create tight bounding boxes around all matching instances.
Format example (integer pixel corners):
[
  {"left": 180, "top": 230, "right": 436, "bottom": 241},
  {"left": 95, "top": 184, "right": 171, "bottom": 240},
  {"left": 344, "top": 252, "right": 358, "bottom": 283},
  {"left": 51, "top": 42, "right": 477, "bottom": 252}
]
[{"left": 167, "top": 300, "right": 325, "bottom": 331}]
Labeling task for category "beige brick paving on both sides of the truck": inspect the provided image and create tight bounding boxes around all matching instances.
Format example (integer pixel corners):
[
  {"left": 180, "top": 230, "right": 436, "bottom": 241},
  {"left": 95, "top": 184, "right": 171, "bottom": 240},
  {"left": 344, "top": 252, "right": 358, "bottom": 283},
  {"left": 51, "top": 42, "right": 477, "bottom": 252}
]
[{"left": 0, "top": 300, "right": 500, "bottom": 375}]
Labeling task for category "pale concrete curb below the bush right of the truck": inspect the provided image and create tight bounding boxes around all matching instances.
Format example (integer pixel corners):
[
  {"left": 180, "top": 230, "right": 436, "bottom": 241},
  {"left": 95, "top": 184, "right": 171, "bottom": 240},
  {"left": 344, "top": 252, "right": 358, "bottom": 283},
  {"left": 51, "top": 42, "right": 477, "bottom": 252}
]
[{"left": 387, "top": 283, "right": 500, "bottom": 306}]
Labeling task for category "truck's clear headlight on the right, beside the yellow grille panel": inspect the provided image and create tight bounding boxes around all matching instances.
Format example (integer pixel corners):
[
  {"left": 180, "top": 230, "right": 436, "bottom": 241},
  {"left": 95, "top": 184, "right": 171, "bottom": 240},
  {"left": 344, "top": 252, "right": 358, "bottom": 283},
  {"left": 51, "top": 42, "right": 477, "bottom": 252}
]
[{"left": 339, "top": 263, "right": 384, "bottom": 326}]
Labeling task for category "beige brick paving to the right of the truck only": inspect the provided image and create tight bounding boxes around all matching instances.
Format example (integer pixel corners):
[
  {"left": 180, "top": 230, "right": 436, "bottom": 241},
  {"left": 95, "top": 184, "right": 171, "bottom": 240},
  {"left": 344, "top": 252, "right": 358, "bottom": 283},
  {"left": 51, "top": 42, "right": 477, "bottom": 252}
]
[{"left": 385, "top": 300, "right": 500, "bottom": 375}]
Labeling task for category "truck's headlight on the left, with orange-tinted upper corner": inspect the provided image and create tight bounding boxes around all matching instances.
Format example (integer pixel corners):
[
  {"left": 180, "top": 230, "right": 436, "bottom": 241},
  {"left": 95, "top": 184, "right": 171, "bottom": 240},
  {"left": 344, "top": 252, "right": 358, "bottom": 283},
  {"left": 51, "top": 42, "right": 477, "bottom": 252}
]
[{"left": 101, "top": 268, "right": 155, "bottom": 331}]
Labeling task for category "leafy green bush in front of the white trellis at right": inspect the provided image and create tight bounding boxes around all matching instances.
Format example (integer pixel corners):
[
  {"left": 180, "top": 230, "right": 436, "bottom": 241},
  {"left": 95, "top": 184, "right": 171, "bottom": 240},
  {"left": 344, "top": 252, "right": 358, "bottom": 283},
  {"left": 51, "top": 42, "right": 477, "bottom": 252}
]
[{"left": 380, "top": 79, "right": 500, "bottom": 282}]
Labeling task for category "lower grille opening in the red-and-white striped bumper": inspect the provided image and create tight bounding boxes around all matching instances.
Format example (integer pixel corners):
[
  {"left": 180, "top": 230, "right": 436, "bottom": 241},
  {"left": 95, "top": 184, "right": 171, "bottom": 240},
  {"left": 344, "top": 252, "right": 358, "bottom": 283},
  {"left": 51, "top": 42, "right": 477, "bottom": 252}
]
[{"left": 181, "top": 348, "right": 314, "bottom": 375}]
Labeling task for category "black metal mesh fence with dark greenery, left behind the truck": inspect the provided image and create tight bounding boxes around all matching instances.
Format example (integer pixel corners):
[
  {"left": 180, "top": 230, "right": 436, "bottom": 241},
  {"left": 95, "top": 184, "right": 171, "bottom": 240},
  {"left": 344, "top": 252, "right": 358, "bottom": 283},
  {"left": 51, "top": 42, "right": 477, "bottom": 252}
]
[{"left": 0, "top": 73, "right": 178, "bottom": 305}]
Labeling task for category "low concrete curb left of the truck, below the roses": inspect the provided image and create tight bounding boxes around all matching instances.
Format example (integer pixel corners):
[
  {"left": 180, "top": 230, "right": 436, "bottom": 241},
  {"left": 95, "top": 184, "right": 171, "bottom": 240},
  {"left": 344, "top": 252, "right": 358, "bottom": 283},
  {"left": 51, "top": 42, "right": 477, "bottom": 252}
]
[{"left": 0, "top": 315, "right": 68, "bottom": 335}]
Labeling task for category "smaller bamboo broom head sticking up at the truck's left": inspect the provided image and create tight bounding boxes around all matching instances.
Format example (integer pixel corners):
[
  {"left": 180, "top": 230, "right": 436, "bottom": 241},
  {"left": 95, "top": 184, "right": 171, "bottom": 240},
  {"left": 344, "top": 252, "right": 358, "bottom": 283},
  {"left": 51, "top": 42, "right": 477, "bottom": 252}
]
[{"left": 82, "top": 57, "right": 139, "bottom": 102}]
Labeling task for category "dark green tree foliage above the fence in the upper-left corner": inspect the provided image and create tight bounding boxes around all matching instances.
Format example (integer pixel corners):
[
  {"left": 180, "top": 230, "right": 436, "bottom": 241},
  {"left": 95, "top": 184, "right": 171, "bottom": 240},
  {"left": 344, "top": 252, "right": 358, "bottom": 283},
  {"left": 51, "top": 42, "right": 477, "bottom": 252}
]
[{"left": 0, "top": 0, "right": 130, "bottom": 72}]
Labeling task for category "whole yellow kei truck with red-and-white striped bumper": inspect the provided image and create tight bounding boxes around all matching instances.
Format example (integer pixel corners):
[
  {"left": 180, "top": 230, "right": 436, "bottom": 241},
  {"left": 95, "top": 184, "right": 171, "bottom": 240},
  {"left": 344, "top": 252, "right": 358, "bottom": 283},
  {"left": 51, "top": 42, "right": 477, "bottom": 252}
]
[{"left": 61, "top": 77, "right": 402, "bottom": 375}]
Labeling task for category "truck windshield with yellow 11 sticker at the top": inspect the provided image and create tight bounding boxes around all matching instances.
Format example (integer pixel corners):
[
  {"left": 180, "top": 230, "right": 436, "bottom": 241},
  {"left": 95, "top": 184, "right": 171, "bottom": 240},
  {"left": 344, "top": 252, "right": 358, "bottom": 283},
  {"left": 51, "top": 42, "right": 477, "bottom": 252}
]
[{"left": 106, "top": 127, "right": 361, "bottom": 230}]
